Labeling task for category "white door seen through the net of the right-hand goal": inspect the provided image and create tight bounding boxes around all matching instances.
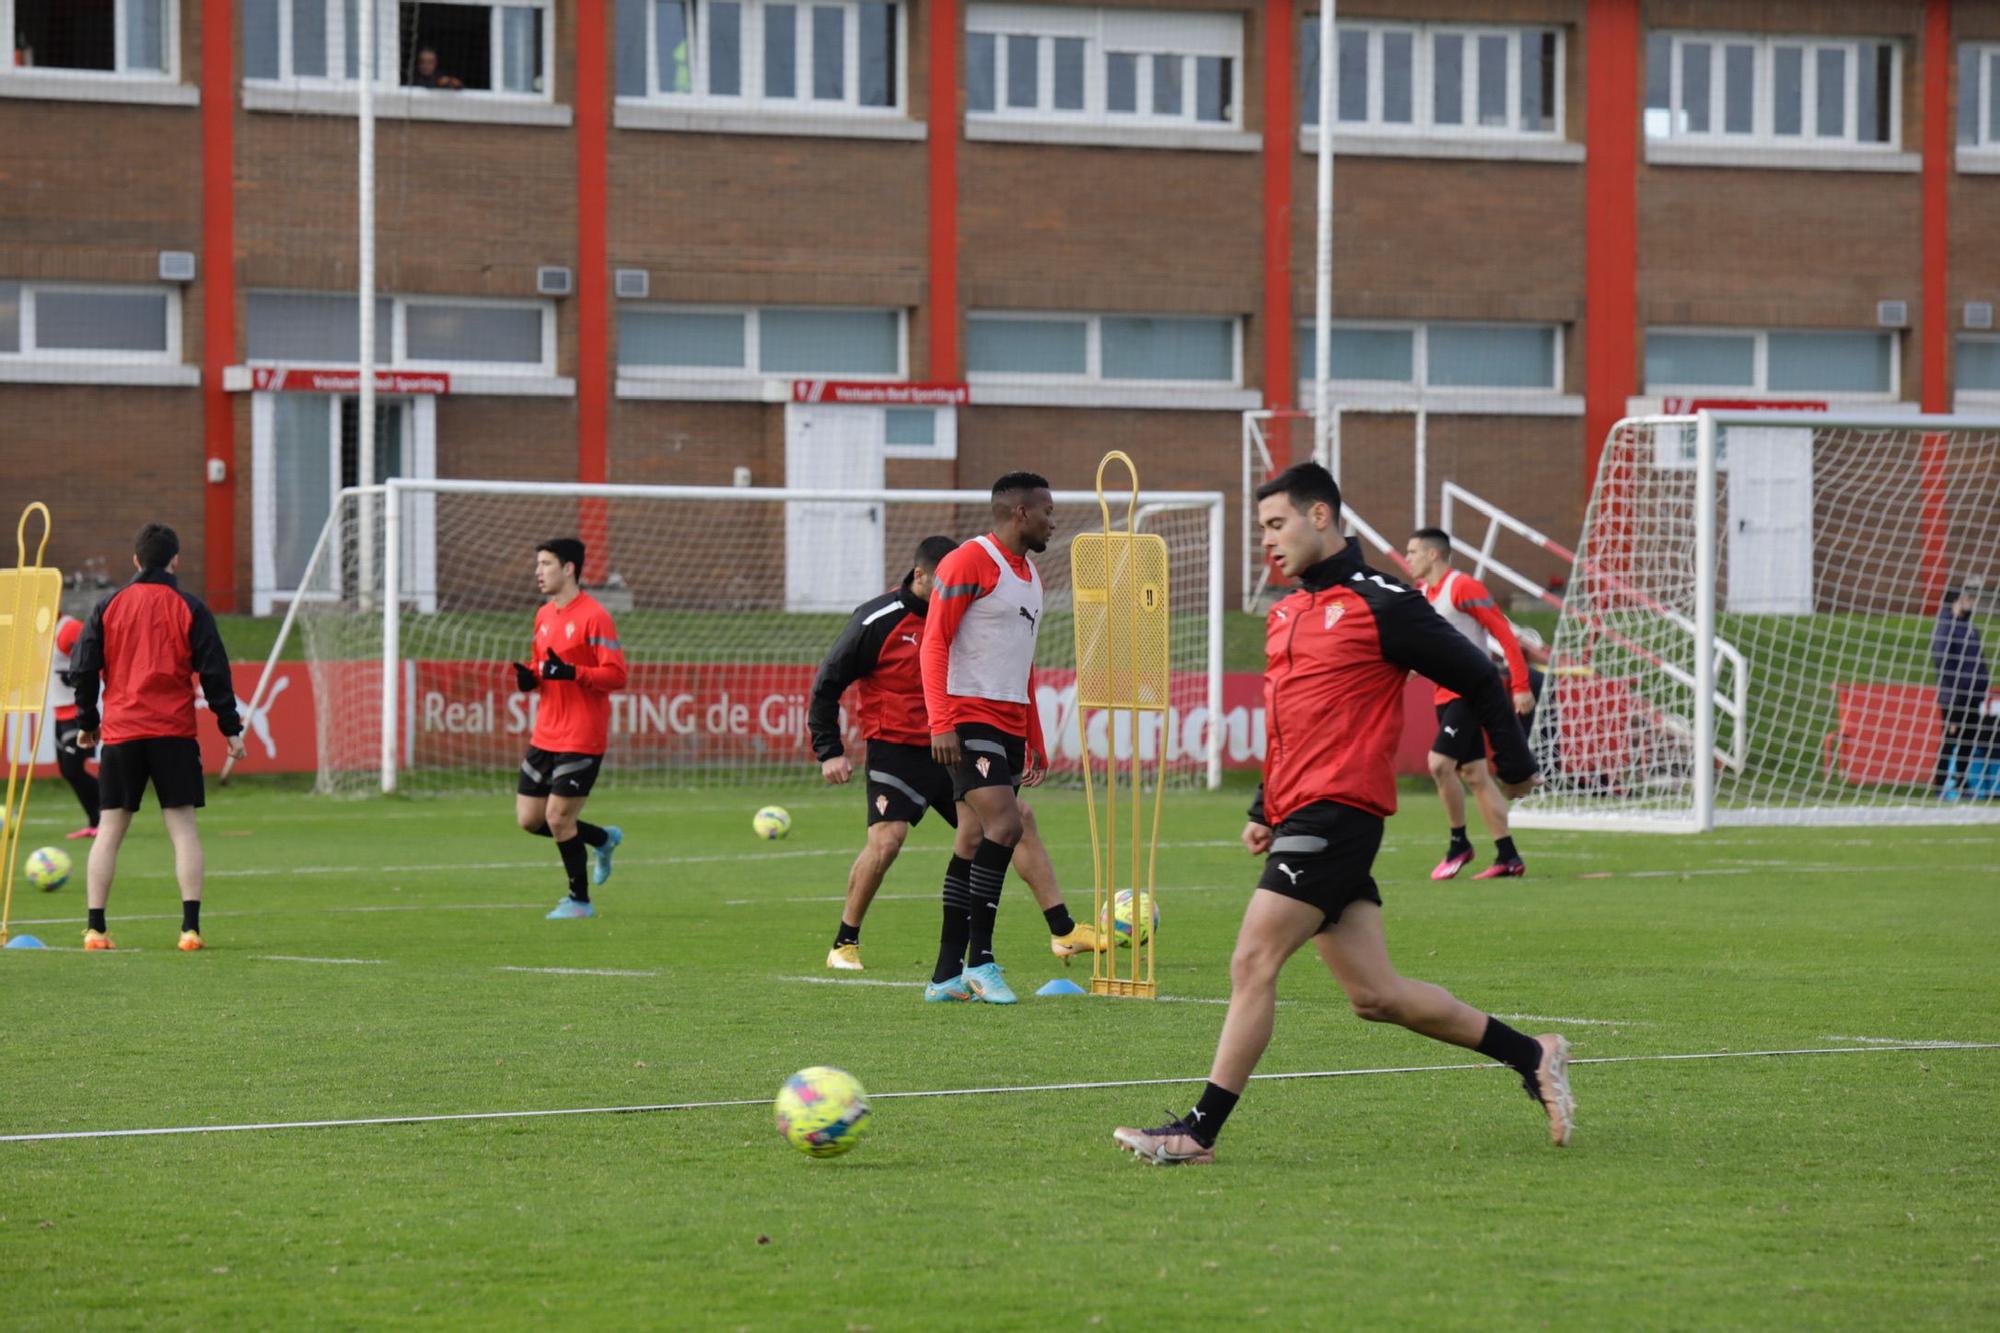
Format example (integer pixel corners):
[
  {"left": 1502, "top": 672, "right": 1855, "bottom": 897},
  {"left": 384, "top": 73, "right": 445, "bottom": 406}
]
[{"left": 1728, "top": 426, "right": 1812, "bottom": 614}]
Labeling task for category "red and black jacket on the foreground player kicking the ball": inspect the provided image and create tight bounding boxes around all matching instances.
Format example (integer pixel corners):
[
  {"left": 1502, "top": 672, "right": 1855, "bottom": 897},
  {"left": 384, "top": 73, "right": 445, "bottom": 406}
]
[{"left": 1250, "top": 538, "right": 1536, "bottom": 825}]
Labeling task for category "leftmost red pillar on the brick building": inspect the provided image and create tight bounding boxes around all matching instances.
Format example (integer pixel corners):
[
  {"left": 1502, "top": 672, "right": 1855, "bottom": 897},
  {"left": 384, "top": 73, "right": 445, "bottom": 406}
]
[{"left": 202, "top": 0, "right": 236, "bottom": 610}]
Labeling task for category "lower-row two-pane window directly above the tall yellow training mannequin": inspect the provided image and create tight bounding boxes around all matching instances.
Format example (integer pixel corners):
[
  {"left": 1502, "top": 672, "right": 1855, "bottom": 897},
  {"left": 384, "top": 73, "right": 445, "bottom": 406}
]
[{"left": 966, "top": 312, "right": 1242, "bottom": 384}]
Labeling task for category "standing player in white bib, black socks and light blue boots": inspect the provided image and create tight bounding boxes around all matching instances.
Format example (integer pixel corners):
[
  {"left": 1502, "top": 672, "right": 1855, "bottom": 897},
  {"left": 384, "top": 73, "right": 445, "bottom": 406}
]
[{"left": 922, "top": 472, "right": 1056, "bottom": 1005}]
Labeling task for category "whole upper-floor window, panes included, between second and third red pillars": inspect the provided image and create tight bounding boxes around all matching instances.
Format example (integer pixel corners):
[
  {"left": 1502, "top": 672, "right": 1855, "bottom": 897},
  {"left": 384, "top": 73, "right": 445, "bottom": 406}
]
[{"left": 618, "top": 0, "right": 904, "bottom": 112}]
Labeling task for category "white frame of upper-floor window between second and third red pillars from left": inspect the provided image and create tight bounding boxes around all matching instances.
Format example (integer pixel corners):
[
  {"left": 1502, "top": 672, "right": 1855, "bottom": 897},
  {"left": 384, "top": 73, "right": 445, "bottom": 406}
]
[{"left": 606, "top": 0, "right": 910, "bottom": 120}]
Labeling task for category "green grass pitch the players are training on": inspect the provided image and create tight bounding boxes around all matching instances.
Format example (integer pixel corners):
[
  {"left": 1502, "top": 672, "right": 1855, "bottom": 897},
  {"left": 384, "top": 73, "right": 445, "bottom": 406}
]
[{"left": 0, "top": 785, "right": 2000, "bottom": 1329}]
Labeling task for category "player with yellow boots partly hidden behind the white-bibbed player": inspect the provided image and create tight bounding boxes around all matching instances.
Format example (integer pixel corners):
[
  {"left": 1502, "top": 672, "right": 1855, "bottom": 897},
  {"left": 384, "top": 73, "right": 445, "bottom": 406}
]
[{"left": 806, "top": 536, "right": 1104, "bottom": 973}]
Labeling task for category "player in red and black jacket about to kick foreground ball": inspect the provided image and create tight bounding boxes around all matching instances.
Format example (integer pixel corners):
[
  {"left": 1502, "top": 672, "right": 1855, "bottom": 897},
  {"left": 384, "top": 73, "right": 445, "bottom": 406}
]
[{"left": 1112, "top": 462, "right": 1574, "bottom": 1167}]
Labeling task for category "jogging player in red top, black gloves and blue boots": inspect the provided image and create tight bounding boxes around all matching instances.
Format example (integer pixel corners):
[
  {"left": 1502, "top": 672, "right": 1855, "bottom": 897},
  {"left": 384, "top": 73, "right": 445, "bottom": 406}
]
[{"left": 512, "top": 536, "right": 626, "bottom": 921}]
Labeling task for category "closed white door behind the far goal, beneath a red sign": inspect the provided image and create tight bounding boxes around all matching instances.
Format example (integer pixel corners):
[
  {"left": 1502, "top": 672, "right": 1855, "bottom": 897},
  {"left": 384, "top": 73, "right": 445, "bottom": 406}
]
[{"left": 784, "top": 402, "right": 884, "bottom": 610}]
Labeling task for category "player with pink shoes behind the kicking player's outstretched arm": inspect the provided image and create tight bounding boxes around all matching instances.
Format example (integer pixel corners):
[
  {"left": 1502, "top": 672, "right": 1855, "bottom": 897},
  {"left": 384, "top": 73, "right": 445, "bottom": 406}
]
[{"left": 1404, "top": 528, "right": 1542, "bottom": 879}]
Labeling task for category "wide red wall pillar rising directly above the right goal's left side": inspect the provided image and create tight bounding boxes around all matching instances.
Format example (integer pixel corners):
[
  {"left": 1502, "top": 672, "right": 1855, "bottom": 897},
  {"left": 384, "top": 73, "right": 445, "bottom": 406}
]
[{"left": 1584, "top": 0, "right": 1644, "bottom": 494}]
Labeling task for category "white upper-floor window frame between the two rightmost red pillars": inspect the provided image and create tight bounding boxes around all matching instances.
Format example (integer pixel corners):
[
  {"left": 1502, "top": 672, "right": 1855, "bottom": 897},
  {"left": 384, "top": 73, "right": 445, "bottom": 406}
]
[{"left": 1640, "top": 28, "right": 1906, "bottom": 152}]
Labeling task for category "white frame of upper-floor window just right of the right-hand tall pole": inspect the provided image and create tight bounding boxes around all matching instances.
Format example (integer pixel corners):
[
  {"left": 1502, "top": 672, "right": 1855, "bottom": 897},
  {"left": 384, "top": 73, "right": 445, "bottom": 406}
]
[{"left": 1300, "top": 14, "right": 1570, "bottom": 142}]
